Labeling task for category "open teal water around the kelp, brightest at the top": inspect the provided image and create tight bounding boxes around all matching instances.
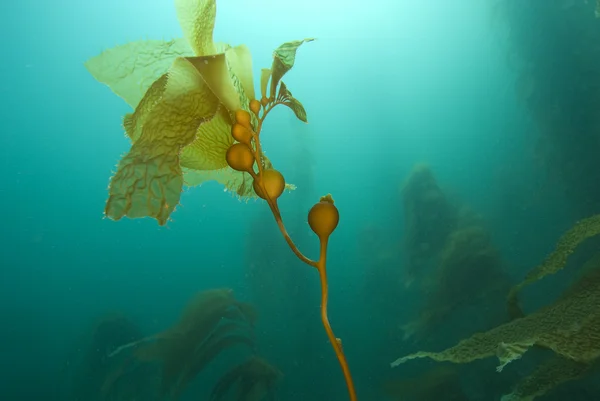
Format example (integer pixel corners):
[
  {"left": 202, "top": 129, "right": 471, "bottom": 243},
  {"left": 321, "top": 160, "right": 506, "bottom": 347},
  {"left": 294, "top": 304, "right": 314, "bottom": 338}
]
[{"left": 0, "top": 0, "right": 600, "bottom": 401}]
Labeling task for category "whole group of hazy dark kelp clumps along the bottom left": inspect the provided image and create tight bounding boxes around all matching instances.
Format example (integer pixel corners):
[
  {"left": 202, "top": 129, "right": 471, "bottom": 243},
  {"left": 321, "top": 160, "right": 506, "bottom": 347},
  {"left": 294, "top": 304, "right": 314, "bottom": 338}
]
[{"left": 74, "top": 288, "right": 282, "bottom": 401}]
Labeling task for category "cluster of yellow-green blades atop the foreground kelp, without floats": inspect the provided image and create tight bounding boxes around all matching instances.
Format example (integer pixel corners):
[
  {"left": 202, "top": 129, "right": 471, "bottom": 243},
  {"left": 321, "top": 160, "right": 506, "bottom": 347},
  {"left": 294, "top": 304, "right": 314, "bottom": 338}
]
[{"left": 86, "top": 0, "right": 312, "bottom": 225}]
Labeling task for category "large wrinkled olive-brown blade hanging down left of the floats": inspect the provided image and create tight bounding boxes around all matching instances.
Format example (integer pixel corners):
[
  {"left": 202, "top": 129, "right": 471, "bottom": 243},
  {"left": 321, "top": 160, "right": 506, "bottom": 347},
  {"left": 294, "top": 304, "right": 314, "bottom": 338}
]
[{"left": 105, "top": 58, "right": 219, "bottom": 225}]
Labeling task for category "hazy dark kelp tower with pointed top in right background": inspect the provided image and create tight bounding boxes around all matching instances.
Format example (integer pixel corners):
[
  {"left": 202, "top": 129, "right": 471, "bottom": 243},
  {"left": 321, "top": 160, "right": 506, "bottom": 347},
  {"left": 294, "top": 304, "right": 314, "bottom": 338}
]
[{"left": 402, "top": 164, "right": 511, "bottom": 339}]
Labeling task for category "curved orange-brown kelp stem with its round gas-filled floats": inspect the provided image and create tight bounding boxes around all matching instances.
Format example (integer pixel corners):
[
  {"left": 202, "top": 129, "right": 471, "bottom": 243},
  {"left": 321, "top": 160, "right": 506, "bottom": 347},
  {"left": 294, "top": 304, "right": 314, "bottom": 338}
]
[{"left": 226, "top": 102, "right": 357, "bottom": 401}]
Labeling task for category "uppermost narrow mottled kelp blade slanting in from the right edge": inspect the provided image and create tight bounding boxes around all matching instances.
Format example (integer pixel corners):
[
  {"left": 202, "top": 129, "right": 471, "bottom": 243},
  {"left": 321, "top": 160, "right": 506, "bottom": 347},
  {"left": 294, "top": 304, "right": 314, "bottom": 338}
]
[{"left": 508, "top": 214, "right": 600, "bottom": 303}]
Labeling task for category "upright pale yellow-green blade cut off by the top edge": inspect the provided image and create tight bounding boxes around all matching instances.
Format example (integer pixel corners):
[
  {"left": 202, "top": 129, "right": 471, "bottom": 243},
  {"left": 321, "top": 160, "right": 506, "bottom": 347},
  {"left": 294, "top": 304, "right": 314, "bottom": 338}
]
[{"left": 175, "top": 0, "right": 217, "bottom": 56}]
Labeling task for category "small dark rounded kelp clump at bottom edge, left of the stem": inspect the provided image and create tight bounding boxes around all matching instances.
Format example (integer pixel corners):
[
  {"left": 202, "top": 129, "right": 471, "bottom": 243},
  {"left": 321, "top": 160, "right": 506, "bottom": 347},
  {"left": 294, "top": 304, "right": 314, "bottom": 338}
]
[{"left": 210, "top": 356, "right": 283, "bottom": 401}]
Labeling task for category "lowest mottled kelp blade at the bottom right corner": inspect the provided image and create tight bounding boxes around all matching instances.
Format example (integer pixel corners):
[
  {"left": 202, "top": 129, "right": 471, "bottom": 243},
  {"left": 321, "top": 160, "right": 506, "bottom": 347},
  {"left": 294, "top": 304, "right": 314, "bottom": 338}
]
[{"left": 500, "top": 355, "right": 591, "bottom": 401}]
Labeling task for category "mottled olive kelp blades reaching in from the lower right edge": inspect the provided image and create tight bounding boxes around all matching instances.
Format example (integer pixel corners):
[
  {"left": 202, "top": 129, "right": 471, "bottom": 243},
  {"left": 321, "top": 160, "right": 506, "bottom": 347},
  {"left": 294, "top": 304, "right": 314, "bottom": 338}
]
[{"left": 391, "top": 215, "right": 600, "bottom": 401}]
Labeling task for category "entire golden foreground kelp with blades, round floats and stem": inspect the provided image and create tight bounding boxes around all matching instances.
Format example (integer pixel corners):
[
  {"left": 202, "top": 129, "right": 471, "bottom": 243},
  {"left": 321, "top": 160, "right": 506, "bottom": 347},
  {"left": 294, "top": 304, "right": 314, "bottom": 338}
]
[{"left": 86, "top": 0, "right": 356, "bottom": 400}]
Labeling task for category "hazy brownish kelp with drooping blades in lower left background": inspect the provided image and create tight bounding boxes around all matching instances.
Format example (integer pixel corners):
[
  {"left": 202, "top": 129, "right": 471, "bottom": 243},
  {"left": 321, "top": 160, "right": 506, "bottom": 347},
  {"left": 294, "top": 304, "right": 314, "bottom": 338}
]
[{"left": 103, "top": 288, "right": 270, "bottom": 399}]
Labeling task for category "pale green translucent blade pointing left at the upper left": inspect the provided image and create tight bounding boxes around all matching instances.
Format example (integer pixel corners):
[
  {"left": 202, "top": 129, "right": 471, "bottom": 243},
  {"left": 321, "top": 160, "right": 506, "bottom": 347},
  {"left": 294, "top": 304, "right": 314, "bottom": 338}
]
[{"left": 85, "top": 39, "right": 194, "bottom": 108}]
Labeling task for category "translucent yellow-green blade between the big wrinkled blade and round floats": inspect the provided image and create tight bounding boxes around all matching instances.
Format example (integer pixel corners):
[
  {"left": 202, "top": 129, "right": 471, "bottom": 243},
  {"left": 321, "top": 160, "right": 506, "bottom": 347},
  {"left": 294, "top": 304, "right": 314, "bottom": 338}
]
[{"left": 181, "top": 107, "right": 233, "bottom": 170}]
